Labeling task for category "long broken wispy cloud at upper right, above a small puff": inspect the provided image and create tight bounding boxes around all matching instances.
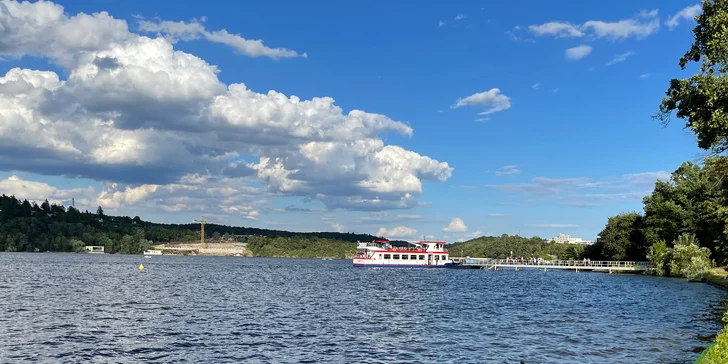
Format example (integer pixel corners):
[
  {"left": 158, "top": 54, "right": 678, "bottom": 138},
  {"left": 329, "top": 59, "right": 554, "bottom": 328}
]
[{"left": 528, "top": 10, "right": 660, "bottom": 40}]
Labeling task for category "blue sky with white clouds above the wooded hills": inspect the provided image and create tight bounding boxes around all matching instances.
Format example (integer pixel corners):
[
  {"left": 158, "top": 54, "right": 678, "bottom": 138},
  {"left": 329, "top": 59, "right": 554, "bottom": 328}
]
[{"left": 0, "top": 0, "right": 705, "bottom": 242}]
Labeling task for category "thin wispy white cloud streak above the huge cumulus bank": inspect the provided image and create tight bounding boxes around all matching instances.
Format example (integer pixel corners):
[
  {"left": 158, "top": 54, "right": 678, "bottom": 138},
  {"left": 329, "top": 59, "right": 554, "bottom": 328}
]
[{"left": 139, "top": 20, "right": 308, "bottom": 59}]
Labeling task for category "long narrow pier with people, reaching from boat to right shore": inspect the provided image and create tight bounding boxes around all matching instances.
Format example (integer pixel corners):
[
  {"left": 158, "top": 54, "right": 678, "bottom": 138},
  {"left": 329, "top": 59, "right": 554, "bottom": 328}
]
[{"left": 450, "top": 257, "right": 654, "bottom": 273}]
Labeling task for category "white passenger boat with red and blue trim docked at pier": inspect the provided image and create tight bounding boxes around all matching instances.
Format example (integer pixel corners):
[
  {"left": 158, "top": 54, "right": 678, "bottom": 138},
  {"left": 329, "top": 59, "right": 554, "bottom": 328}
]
[{"left": 353, "top": 239, "right": 452, "bottom": 268}]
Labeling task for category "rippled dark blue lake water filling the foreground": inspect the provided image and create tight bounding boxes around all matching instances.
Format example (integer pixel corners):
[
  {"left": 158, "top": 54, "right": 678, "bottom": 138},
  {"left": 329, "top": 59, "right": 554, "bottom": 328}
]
[{"left": 0, "top": 253, "right": 725, "bottom": 363}]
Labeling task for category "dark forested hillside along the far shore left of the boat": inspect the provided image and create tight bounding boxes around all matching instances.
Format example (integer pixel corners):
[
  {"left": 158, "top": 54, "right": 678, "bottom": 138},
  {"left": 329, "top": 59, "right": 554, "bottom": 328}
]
[{"left": 0, "top": 195, "right": 375, "bottom": 256}]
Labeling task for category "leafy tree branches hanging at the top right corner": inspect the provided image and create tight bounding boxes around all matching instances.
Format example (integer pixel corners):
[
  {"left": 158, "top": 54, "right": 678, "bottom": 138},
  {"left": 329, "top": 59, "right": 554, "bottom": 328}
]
[{"left": 656, "top": 0, "right": 728, "bottom": 153}]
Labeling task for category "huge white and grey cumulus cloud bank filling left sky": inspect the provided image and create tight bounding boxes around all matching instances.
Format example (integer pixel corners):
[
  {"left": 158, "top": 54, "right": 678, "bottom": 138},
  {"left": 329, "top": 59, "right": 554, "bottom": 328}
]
[{"left": 0, "top": 1, "right": 453, "bottom": 219}]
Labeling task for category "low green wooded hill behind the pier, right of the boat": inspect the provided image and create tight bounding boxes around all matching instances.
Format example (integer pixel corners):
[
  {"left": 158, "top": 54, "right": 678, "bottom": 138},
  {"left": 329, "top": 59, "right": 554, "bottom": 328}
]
[{"left": 448, "top": 234, "right": 583, "bottom": 260}]
